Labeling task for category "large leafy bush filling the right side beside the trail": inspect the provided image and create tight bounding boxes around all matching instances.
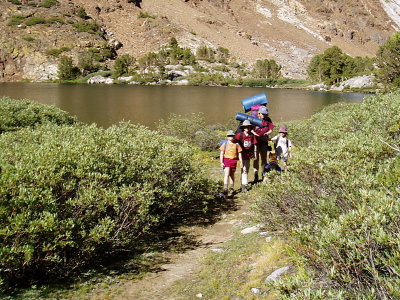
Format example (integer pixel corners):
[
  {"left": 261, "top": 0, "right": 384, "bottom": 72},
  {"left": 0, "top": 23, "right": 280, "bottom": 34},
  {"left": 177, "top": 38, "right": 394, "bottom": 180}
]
[{"left": 255, "top": 93, "right": 400, "bottom": 299}]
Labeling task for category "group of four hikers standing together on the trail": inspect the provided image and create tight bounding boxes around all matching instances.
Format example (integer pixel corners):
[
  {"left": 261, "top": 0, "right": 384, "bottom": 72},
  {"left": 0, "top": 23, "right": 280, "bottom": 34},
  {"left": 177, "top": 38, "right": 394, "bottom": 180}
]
[{"left": 220, "top": 99, "right": 292, "bottom": 195}]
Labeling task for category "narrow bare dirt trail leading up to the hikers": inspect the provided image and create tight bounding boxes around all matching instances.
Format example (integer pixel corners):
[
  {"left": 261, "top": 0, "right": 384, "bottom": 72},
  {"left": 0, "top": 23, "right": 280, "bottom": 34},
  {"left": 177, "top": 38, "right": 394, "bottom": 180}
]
[{"left": 91, "top": 189, "right": 252, "bottom": 300}]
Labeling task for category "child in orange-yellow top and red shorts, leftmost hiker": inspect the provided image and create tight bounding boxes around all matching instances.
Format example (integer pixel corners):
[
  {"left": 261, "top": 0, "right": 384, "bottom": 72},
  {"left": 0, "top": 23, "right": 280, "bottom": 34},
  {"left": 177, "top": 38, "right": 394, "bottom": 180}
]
[{"left": 219, "top": 130, "right": 243, "bottom": 195}]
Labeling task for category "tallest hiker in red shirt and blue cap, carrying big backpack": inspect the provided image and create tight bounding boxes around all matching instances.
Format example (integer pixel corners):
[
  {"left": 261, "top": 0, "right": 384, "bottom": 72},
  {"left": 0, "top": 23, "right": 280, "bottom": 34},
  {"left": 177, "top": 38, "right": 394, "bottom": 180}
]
[{"left": 253, "top": 106, "right": 275, "bottom": 182}]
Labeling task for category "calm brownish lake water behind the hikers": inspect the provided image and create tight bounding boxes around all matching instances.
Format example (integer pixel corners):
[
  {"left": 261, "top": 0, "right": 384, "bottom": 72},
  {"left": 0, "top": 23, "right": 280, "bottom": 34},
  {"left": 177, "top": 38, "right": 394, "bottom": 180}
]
[{"left": 0, "top": 83, "right": 366, "bottom": 128}]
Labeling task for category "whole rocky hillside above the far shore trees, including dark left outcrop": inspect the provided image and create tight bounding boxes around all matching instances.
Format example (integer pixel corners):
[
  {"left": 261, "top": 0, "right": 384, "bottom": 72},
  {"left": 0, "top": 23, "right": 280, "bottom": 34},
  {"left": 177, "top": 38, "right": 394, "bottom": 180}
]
[{"left": 0, "top": 0, "right": 400, "bottom": 81}]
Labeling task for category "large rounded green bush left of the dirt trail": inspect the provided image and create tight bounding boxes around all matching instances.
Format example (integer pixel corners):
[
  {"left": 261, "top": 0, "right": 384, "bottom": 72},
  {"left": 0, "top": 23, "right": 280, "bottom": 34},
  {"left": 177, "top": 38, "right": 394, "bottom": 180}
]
[{"left": 0, "top": 124, "right": 215, "bottom": 288}]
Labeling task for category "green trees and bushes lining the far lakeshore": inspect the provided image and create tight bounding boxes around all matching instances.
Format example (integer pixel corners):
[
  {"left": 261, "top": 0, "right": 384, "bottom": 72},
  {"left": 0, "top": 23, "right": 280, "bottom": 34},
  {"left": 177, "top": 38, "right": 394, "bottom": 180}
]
[{"left": 58, "top": 32, "right": 400, "bottom": 88}]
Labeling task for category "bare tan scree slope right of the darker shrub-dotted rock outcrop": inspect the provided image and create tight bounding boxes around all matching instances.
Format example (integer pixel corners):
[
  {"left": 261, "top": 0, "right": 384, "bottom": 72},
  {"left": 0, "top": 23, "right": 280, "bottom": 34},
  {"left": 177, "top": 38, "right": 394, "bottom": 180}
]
[{"left": 0, "top": 0, "right": 400, "bottom": 78}]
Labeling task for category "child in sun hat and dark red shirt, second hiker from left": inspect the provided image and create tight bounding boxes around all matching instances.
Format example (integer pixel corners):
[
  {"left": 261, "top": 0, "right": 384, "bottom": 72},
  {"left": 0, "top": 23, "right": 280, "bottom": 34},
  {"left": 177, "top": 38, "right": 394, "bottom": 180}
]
[{"left": 235, "top": 120, "right": 257, "bottom": 192}]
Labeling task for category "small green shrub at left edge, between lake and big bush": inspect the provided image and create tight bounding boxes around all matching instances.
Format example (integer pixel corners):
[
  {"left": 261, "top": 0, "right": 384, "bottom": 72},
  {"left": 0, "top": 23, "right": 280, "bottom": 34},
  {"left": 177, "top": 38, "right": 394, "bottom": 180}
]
[{"left": 0, "top": 97, "right": 76, "bottom": 134}]
